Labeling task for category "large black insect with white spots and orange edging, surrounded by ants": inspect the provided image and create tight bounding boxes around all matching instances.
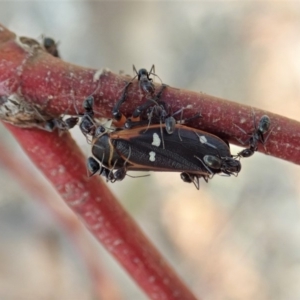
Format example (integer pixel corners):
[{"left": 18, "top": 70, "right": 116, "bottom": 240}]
[{"left": 80, "top": 81, "right": 241, "bottom": 188}]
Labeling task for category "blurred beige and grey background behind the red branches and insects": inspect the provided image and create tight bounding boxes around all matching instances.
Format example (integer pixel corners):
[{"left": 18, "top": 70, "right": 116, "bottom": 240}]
[{"left": 0, "top": 1, "right": 300, "bottom": 300}]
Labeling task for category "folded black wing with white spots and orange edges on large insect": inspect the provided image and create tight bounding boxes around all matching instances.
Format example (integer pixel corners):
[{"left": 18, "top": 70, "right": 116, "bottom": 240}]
[{"left": 111, "top": 124, "right": 230, "bottom": 174}]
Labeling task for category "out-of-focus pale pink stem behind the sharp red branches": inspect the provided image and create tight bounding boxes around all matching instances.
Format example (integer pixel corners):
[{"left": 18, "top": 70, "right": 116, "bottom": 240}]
[{"left": 0, "top": 145, "right": 121, "bottom": 300}]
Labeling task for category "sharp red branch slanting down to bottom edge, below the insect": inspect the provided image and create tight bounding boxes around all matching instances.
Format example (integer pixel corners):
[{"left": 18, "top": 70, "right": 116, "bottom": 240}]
[{"left": 6, "top": 124, "right": 195, "bottom": 299}]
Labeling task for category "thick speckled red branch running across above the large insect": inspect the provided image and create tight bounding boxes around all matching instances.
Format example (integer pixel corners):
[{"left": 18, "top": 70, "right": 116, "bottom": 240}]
[{"left": 0, "top": 25, "right": 300, "bottom": 164}]
